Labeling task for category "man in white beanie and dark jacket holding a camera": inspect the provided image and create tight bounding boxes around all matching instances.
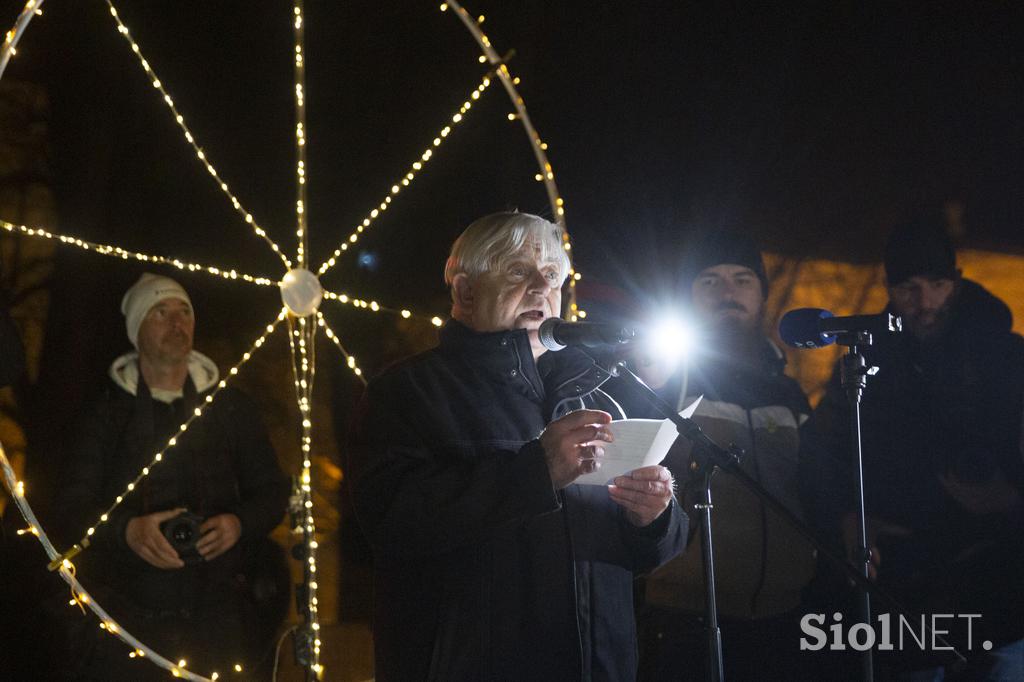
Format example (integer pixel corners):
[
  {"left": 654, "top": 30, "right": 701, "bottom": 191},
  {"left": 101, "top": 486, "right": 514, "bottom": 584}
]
[{"left": 55, "top": 273, "right": 288, "bottom": 680}]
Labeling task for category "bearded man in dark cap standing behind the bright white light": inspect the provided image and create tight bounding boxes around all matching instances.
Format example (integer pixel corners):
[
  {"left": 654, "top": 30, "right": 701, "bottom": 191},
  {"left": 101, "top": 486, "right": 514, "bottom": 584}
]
[{"left": 615, "top": 229, "right": 817, "bottom": 682}]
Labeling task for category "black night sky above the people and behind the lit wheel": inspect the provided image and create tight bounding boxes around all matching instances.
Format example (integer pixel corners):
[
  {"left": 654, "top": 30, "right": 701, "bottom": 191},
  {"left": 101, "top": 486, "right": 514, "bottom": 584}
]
[{"left": 7, "top": 0, "right": 1024, "bottom": 376}]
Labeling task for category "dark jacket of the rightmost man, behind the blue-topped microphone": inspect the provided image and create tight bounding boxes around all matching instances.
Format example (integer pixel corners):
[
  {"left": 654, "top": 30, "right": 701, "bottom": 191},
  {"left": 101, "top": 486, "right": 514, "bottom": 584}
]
[{"left": 815, "top": 280, "right": 1024, "bottom": 646}]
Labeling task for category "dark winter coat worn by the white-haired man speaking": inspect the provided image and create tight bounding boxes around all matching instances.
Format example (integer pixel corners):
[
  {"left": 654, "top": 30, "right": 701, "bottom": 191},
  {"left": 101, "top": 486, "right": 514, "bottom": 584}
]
[{"left": 348, "top": 322, "right": 686, "bottom": 682}]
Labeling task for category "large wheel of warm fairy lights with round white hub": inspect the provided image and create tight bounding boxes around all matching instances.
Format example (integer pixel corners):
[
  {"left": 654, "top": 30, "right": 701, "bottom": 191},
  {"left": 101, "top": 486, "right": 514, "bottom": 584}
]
[{"left": 0, "top": 0, "right": 586, "bottom": 680}]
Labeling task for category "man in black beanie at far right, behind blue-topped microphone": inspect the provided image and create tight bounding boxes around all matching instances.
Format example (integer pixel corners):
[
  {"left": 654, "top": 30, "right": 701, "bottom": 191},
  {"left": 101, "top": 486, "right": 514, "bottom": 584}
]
[{"left": 815, "top": 220, "right": 1024, "bottom": 680}]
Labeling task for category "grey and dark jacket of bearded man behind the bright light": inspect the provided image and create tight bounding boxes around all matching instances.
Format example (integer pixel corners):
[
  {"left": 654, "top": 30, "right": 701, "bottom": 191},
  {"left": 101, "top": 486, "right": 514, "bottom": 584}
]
[{"left": 609, "top": 339, "right": 819, "bottom": 622}]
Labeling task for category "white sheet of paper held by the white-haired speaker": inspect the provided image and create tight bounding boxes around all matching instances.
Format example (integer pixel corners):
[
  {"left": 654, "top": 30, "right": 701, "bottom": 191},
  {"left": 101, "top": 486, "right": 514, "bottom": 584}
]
[{"left": 573, "top": 395, "right": 703, "bottom": 485}]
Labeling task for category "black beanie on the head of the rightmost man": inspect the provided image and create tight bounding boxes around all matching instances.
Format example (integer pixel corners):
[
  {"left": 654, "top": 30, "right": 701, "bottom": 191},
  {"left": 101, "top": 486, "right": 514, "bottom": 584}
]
[{"left": 886, "top": 218, "right": 956, "bottom": 287}]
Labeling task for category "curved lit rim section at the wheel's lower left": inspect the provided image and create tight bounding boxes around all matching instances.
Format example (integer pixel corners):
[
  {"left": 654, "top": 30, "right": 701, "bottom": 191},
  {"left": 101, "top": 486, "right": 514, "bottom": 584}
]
[{"left": 0, "top": 443, "right": 210, "bottom": 682}]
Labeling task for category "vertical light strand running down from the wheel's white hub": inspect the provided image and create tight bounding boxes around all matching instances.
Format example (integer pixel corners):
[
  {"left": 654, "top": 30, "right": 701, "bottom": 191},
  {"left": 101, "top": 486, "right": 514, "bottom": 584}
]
[{"left": 288, "top": 311, "right": 323, "bottom": 677}]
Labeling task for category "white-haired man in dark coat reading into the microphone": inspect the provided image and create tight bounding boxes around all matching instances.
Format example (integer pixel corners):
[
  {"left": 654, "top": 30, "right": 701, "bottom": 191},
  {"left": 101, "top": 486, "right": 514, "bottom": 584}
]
[{"left": 347, "top": 213, "right": 687, "bottom": 682}]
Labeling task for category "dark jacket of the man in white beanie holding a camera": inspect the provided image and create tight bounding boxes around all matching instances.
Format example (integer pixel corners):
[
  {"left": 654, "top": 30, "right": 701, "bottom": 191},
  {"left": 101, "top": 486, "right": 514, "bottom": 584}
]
[{"left": 55, "top": 352, "right": 288, "bottom": 615}]
